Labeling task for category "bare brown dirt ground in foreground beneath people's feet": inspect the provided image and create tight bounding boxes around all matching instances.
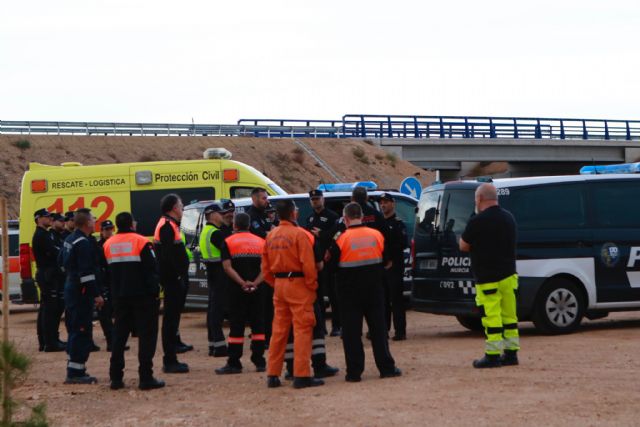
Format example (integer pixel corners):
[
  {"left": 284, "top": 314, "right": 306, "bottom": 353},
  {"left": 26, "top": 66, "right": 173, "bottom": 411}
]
[{"left": 11, "top": 312, "right": 640, "bottom": 426}]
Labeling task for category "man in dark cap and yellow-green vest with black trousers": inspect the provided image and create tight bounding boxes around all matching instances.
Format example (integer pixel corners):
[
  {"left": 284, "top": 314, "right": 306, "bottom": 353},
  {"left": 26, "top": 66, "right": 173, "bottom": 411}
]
[{"left": 200, "top": 199, "right": 235, "bottom": 357}]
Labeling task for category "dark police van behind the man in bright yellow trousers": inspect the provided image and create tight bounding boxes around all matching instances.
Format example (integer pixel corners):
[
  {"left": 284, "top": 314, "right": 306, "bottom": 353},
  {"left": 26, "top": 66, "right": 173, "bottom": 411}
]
[{"left": 411, "top": 167, "right": 640, "bottom": 333}]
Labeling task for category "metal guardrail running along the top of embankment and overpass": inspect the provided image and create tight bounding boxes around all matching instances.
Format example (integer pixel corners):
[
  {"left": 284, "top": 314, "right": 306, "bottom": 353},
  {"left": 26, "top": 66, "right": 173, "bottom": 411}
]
[{"left": 0, "top": 114, "right": 640, "bottom": 141}]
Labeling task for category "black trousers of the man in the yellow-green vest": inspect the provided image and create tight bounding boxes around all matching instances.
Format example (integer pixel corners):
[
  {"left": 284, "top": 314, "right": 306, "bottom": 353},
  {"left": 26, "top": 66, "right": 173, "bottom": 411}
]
[{"left": 207, "top": 263, "right": 228, "bottom": 350}]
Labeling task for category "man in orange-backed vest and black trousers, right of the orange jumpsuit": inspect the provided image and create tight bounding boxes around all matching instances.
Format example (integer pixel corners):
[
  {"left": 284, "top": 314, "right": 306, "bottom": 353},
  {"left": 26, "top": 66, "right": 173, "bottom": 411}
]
[{"left": 331, "top": 203, "right": 402, "bottom": 382}]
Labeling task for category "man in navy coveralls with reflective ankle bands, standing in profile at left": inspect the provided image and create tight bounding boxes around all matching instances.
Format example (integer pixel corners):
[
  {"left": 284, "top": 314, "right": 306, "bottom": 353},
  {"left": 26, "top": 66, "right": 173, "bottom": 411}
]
[{"left": 62, "top": 208, "right": 104, "bottom": 384}]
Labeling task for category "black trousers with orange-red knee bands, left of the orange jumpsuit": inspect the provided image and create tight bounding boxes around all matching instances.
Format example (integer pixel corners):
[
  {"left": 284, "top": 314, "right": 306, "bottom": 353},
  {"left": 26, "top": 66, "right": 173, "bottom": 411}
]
[{"left": 228, "top": 283, "right": 270, "bottom": 368}]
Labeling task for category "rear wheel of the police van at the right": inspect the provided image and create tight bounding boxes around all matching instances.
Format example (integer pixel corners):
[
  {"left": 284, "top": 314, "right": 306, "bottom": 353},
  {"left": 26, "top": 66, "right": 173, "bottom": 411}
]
[{"left": 532, "top": 278, "right": 585, "bottom": 334}]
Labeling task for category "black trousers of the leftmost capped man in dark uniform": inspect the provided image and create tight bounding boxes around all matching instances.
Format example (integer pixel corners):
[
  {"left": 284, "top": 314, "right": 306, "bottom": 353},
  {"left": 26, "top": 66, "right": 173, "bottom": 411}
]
[{"left": 36, "top": 269, "right": 64, "bottom": 347}]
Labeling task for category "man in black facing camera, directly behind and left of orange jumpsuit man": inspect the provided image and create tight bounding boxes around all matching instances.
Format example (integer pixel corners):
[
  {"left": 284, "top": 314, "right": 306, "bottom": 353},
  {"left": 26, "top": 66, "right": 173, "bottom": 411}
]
[{"left": 247, "top": 187, "right": 273, "bottom": 348}]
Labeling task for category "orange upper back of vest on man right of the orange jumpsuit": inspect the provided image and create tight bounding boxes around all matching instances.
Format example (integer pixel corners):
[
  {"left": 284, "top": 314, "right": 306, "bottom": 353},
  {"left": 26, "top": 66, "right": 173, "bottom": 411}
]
[{"left": 336, "top": 227, "right": 384, "bottom": 268}]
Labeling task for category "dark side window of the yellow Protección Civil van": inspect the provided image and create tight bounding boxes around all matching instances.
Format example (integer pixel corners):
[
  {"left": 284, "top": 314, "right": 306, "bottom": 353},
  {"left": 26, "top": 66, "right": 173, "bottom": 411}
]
[{"left": 131, "top": 187, "right": 215, "bottom": 236}]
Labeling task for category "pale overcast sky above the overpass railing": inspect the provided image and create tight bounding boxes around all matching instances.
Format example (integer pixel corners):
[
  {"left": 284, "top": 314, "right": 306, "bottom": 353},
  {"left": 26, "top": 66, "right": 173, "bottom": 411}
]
[{"left": 0, "top": 0, "right": 640, "bottom": 124}]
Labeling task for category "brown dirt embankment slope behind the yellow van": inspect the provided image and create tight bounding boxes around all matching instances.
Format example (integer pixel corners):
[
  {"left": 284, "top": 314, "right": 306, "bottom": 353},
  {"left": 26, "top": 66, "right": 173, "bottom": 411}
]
[{"left": 0, "top": 135, "right": 435, "bottom": 218}]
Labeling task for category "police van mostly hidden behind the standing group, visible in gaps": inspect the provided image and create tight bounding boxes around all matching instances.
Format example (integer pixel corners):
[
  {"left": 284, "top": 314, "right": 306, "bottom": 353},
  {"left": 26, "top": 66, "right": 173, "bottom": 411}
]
[{"left": 180, "top": 190, "right": 418, "bottom": 308}]
